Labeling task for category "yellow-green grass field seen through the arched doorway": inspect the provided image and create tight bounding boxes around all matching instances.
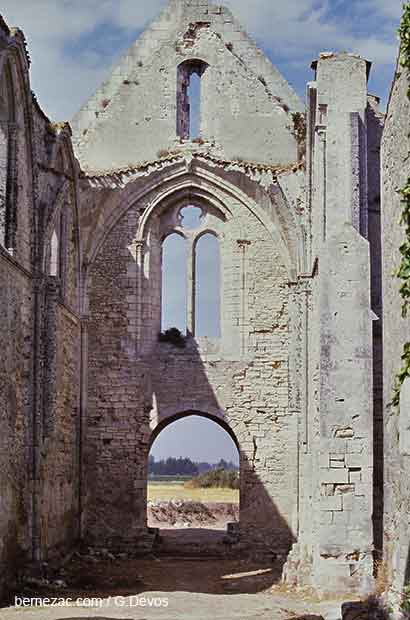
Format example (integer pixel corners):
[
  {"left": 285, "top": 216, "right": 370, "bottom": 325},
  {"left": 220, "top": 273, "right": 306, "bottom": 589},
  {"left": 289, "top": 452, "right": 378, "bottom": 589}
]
[{"left": 148, "top": 480, "right": 239, "bottom": 504}]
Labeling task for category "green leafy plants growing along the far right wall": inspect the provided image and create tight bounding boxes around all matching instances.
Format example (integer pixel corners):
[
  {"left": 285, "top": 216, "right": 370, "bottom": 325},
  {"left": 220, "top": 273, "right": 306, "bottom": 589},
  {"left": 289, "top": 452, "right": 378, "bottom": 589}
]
[{"left": 392, "top": 3, "right": 410, "bottom": 406}]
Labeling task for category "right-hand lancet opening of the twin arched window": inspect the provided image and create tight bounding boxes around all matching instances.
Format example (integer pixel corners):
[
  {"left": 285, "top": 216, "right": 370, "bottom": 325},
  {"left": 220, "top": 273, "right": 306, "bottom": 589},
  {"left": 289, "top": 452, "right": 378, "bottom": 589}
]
[{"left": 195, "top": 233, "right": 221, "bottom": 338}]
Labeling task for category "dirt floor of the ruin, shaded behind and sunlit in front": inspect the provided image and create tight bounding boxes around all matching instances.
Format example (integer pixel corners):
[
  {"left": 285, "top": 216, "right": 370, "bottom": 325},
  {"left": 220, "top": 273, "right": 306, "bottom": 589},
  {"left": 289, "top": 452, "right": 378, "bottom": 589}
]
[{"left": 0, "top": 553, "right": 346, "bottom": 620}]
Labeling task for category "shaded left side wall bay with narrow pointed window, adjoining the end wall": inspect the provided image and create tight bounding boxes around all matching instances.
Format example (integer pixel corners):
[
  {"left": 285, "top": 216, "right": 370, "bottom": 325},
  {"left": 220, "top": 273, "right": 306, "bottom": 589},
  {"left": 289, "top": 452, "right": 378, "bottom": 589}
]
[{"left": 33, "top": 128, "right": 82, "bottom": 560}]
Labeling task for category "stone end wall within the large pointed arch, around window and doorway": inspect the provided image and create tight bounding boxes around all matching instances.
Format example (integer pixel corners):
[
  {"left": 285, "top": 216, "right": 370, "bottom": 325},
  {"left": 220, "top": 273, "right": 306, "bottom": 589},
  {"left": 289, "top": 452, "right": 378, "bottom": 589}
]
[{"left": 85, "top": 163, "right": 297, "bottom": 553}]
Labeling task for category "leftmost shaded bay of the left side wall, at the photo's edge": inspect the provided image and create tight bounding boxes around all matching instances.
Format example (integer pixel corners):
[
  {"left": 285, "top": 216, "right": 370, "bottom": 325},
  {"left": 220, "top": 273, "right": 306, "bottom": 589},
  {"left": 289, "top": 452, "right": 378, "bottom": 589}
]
[{"left": 0, "top": 29, "right": 33, "bottom": 596}]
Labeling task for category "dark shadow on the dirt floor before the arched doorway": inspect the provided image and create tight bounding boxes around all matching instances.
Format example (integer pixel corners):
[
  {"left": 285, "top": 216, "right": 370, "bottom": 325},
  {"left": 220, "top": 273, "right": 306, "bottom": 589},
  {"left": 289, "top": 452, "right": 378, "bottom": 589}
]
[{"left": 8, "top": 556, "right": 282, "bottom": 598}]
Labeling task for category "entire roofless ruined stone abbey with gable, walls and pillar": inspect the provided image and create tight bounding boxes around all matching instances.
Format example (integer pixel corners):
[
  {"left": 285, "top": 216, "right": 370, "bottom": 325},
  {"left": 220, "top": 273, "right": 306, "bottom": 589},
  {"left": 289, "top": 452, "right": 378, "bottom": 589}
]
[{"left": 0, "top": 0, "right": 410, "bottom": 594}]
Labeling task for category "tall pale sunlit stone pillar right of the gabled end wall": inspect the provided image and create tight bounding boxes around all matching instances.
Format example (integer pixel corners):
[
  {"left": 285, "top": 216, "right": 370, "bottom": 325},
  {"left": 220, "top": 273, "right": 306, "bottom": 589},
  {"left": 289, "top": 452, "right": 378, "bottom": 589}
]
[{"left": 312, "top": 54, "right": 373, "bottom": 594}]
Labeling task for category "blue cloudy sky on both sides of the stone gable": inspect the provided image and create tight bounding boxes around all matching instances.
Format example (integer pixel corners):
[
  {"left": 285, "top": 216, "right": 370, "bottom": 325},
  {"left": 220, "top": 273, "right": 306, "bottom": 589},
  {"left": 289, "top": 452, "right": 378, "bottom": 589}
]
[{"left": 2, "top": 0, "right": 402, "bottom": 118}]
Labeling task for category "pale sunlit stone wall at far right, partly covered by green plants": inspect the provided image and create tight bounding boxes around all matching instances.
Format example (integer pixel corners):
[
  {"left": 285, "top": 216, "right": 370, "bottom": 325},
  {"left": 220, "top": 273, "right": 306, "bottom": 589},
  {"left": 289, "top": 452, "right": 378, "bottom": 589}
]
[{"left": 382, "top": 58, "right": 410, "bottom": 593}]
